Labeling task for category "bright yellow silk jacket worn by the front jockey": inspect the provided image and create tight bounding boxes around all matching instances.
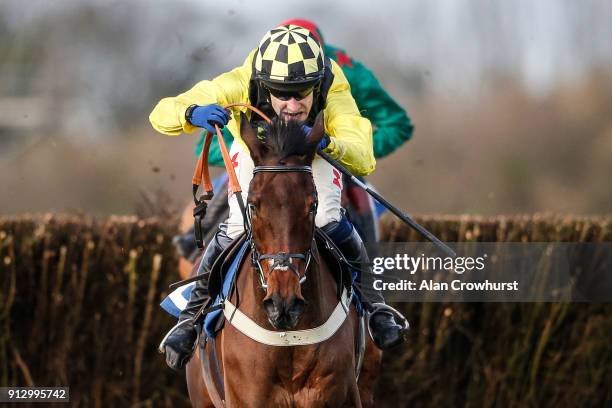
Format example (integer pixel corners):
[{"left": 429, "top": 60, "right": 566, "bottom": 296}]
[{"left": 149, "top": 50, "right": 376, "bottom": 176}]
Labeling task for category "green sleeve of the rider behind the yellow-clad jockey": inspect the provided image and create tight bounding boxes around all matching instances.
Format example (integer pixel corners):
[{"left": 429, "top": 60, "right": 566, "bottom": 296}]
[{"left": 325, "top": 46, "right": 414, "bottom": 159}]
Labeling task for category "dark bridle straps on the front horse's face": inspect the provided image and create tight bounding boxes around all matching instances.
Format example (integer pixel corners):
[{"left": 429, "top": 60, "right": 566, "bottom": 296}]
[{"left": 245, "top": 166, "right": 318, "bottom": 290}]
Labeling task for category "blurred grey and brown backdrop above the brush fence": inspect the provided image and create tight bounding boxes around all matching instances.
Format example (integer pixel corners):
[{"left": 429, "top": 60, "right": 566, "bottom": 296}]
[{"left": 0, "top": 0, "right": 612, "bottom": 215}]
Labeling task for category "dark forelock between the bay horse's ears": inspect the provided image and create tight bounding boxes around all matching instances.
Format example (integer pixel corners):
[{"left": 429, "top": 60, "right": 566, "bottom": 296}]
[{"left": 263, "top": 117, "right": 317, "bottom": 158}]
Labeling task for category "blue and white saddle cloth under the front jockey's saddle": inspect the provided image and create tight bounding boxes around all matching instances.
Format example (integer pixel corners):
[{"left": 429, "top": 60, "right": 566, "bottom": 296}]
[{"left": 160, "top": 241, "right": 363, "bottom": 337}]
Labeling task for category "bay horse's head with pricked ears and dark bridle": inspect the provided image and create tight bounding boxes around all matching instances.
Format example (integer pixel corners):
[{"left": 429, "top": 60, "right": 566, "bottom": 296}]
[{"left": 240, "top": 113, "right": 324, "bottom": 329}]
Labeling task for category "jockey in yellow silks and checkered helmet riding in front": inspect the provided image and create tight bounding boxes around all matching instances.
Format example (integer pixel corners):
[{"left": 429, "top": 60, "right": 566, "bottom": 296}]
[{"left": 149, "top": 24, "right": 403, "bottom": 369}]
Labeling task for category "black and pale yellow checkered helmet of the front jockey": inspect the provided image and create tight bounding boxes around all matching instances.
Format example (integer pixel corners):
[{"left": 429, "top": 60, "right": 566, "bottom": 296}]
[{"left": 254, "top": 24, "right": 325, "bottom": 89}]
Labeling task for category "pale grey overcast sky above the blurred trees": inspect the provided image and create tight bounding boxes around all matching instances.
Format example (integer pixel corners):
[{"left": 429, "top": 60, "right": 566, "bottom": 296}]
[{"left": 4, "top": 0, "right": 612, "bottom": 99}]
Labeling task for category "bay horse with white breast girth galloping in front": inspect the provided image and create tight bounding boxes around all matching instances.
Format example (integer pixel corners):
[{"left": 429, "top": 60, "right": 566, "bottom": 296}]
[{"left": 186, "top": 113, "right": 382, "bottom": 407}]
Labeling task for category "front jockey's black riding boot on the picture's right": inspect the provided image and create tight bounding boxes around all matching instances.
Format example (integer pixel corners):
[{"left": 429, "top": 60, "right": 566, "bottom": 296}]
[{"left": 323, "top": 216, "right": 405, "bottom": 350}]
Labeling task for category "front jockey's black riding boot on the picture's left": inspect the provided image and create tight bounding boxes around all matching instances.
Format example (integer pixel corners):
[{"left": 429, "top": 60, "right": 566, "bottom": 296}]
[{"left": 160, "top": 229, "right": 232, "bottom": 370}]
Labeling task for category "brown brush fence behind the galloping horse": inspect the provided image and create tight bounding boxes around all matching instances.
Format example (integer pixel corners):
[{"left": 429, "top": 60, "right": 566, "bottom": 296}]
[{"left": 0, "top": 215, "right": 612, "bottom": 407}]
